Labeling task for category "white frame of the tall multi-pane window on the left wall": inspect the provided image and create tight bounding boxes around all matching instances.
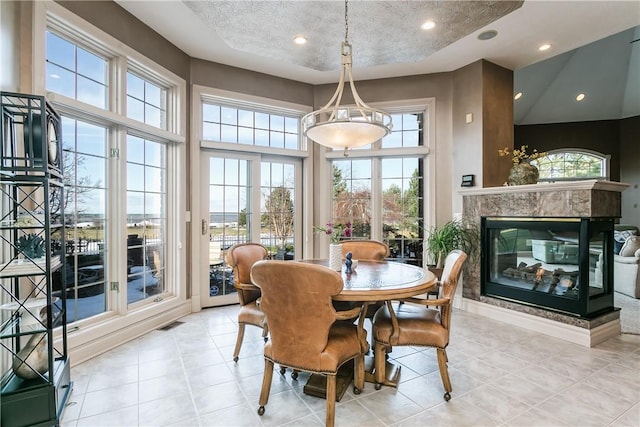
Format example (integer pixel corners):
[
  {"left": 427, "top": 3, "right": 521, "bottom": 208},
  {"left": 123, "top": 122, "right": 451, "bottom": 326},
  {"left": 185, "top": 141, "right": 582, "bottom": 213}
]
[{"left": 31, "top": 1, "right": 190, "bottom": 361}]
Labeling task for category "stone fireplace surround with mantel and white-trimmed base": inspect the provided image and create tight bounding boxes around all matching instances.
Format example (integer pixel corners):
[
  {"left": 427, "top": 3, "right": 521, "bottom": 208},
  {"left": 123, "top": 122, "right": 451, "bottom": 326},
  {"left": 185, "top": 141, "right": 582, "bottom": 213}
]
[{"left": 460, "top": 180, "right": 629, "bottom": 347}]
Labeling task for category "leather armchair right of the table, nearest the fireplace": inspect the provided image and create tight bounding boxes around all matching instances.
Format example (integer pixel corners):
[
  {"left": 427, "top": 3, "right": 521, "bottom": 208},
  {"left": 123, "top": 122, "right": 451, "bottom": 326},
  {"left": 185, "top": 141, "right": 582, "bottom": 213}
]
[{"left": 373, "top": 249, "right": 467, "bottom": 401}]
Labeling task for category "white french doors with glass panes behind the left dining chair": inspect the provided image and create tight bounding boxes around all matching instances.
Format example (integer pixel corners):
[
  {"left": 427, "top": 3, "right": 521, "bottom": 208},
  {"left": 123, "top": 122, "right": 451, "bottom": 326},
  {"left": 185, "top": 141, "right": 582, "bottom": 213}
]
[{"left": 200, "top": 151, "right": 302, "bottom": 307}]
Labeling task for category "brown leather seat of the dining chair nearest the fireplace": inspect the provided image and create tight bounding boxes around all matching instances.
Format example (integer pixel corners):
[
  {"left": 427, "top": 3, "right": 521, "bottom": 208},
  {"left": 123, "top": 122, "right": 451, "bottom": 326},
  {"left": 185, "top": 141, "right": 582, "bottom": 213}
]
[{"left": 373, "top": 304, "right": 449, "bottom": 347}]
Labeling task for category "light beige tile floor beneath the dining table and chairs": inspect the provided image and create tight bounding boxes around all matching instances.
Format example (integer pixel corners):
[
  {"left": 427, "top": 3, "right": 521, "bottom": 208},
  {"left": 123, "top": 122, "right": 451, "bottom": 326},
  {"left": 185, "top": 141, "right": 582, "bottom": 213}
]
[{"left": 61, "top": 306, "right": 640, "bottom": 427}]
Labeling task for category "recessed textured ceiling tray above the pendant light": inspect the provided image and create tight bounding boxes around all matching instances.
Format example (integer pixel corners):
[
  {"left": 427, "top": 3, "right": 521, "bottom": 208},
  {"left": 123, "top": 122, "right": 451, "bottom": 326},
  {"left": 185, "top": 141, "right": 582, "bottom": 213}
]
[{"left": 184, "top": 1, "right": 523, "bottom": 71}]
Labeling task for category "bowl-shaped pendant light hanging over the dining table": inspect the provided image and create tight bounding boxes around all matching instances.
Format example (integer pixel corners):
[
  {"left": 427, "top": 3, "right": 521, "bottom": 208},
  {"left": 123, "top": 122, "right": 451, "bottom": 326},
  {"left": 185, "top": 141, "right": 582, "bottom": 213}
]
[{"left": 302, "top": 0, "right": 393, "bottom": 156}]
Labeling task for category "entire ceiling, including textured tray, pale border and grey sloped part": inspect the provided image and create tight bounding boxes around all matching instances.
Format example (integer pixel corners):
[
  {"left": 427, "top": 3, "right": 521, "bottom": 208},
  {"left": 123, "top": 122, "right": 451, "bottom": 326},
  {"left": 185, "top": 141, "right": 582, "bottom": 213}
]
[{"left": 115, "top": 0, "right": 640, "bottom": 124}]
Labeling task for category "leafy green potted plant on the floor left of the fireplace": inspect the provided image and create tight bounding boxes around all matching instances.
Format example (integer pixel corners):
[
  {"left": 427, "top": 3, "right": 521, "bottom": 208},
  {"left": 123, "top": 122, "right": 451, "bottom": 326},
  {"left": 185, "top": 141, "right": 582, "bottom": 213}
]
[{"left": 426, "top": 220, "right": 480, "bottom": 278}]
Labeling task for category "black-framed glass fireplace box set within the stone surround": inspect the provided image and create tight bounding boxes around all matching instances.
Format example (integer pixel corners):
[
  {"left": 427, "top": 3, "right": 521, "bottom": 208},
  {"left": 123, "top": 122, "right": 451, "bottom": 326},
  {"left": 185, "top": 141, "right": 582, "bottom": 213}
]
[{"left": 480, "top": 216, "right": 614, "bottom": 319}]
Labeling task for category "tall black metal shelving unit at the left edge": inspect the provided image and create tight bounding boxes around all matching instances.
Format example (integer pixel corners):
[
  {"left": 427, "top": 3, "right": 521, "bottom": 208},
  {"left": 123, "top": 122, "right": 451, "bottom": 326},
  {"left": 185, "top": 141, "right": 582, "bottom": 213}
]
[{"left": 0, "top": 92, "right": 72, "bottom": 427}]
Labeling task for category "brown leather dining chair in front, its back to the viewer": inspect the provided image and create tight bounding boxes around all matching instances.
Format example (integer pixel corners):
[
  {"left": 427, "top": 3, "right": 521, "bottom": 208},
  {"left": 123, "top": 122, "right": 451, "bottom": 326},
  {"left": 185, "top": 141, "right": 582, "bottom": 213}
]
[{"left": 251, "top": 261, "right": 367, "bottom": 426}]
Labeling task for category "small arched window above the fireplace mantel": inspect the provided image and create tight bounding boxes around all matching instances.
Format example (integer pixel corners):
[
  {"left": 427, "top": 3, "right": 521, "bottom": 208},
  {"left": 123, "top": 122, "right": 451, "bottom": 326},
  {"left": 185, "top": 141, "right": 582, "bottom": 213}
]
[{"left": 531, "top": 149, "right": 610, "bottom": 182}]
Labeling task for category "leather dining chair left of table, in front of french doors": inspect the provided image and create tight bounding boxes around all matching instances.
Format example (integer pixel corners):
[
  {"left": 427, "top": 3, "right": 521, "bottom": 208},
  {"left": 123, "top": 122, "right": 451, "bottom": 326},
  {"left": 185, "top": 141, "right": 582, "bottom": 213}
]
[{"left": 226, "top": 243, "right": 269, "bottom": 362}]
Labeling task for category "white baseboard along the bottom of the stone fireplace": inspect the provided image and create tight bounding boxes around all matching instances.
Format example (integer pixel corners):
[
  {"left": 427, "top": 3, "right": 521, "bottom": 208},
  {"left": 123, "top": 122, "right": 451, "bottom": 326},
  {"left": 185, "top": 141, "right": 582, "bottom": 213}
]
[{"left": 458, "top": 298, "right": 621, "bottom": 347}]
